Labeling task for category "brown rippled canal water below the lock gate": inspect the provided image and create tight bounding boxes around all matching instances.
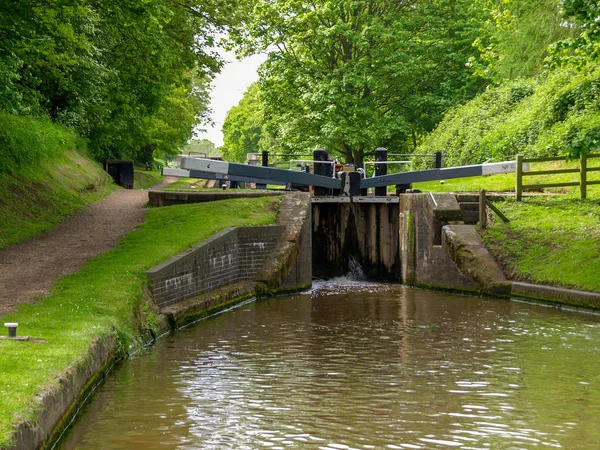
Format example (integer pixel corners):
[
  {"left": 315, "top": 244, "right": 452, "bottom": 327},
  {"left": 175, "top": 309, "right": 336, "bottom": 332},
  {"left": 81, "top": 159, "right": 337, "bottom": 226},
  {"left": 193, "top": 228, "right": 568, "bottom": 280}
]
[{"left": 61, "top": 280, "right": 600, "bottom": 450}]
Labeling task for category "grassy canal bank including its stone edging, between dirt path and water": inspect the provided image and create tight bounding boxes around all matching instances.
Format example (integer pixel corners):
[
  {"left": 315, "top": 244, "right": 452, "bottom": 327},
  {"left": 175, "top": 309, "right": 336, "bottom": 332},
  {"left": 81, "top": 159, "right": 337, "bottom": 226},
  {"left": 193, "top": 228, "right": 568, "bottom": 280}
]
[{"left": 0, "top": 197, "right": 290, "bottom": 449}]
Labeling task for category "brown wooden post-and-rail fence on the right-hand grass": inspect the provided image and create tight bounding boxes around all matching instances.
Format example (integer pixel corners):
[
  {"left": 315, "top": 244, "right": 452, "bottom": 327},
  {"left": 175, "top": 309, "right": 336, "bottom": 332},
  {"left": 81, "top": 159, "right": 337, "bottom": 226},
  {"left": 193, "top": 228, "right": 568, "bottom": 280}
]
[{"left": 516, "top": 153, "right": 600, "bottom": 201}]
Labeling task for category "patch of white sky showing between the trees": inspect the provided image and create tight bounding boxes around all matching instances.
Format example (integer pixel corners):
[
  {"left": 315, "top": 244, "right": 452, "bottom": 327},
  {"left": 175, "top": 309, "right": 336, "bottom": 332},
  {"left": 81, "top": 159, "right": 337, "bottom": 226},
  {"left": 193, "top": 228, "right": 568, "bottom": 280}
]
[{"left": 196, "top": 50, "right": 267, "bottom": 147}]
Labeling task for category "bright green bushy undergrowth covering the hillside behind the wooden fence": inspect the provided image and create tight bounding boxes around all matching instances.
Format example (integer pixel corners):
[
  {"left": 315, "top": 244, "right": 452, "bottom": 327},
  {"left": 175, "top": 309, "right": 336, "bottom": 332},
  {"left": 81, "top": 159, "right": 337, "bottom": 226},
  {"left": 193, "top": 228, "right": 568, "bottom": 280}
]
[{"left": 421, "top": 65, "right": 600, "bottom": 165}]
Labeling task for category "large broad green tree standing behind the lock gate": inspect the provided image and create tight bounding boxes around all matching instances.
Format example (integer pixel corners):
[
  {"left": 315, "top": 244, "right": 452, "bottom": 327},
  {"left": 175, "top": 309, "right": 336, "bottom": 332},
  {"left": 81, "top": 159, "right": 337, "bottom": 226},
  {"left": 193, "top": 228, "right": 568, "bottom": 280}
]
[{"left": 232, "top": 0, "right": 488, "bottom": 164}]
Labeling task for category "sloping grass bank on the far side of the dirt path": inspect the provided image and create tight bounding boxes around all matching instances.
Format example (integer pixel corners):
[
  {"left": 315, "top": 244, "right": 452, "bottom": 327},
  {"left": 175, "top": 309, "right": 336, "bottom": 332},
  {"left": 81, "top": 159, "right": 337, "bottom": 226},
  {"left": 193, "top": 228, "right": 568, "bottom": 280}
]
[{"left": 0, "top": 149, "right": 114, "bottom": 249}]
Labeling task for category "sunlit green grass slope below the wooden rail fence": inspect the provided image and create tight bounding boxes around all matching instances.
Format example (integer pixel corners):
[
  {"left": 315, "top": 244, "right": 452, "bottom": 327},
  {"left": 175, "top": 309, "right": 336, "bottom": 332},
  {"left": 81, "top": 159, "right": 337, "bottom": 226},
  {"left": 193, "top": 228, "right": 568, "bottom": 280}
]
[{"left": 484, "top": 196, "right": 600, "bottom": 292}]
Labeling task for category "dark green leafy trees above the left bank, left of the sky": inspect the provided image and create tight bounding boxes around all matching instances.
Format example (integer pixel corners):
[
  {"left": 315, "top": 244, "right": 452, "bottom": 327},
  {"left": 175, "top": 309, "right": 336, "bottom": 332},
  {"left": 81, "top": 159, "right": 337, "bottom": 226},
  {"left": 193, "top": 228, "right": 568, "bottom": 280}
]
[{"left": 0, "top": 0, "right": 239, "bottom": 161}]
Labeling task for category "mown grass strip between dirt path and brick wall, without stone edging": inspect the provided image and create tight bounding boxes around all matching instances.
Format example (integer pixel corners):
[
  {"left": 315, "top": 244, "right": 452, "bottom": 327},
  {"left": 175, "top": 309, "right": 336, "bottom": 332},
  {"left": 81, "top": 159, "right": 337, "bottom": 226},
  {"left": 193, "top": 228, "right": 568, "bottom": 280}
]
[{"left": 0, "top": 197, "right": 280, "bottom": 448}]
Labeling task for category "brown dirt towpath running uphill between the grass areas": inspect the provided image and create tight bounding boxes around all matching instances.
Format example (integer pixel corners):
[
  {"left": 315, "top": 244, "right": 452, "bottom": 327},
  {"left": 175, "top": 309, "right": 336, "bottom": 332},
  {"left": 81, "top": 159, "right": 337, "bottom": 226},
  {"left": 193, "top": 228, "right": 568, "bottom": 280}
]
[{"left": 0, "top": 177, "right": 176, "bottom": 316}]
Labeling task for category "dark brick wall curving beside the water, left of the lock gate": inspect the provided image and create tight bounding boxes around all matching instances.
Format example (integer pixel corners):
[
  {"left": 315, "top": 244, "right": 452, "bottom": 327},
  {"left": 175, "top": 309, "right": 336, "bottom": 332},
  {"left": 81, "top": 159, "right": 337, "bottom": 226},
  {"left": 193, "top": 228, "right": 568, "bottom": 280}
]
[{"left": 146, "top": 225, "right": 285, "bottom": 308}]
